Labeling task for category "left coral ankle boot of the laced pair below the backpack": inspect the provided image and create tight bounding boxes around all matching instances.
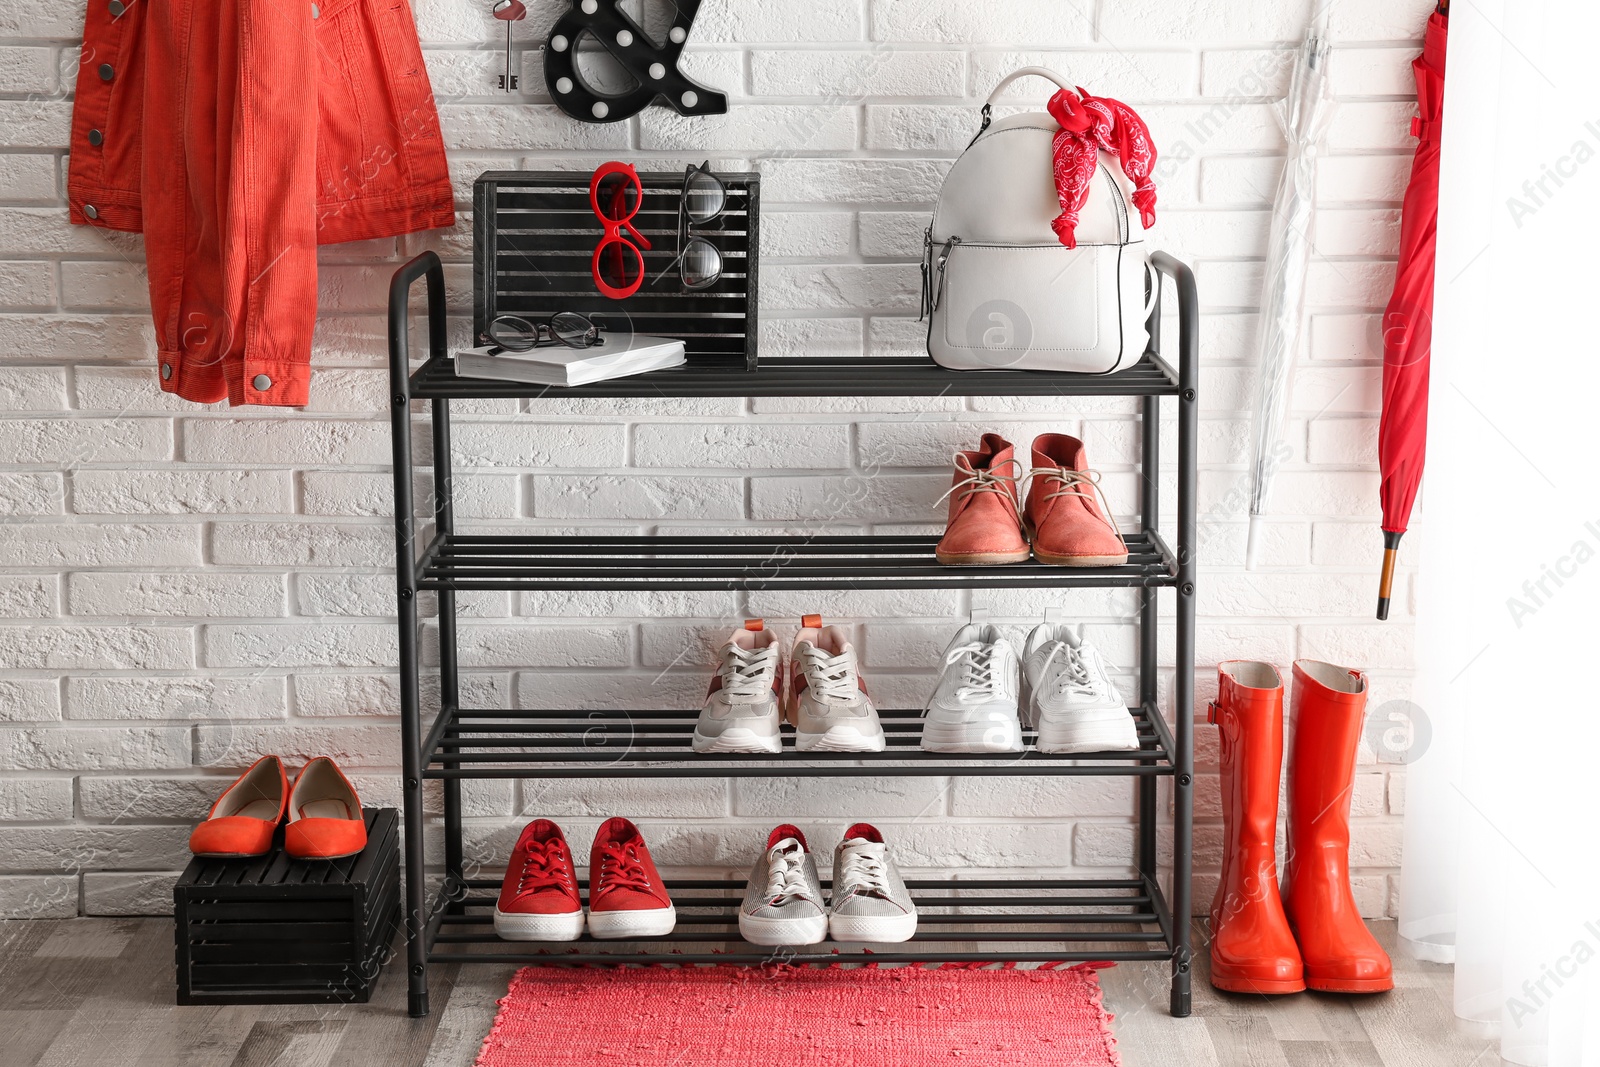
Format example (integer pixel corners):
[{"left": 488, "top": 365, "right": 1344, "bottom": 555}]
[{"left": 933, "top": 434, "right": 1029, "bottom": 566}]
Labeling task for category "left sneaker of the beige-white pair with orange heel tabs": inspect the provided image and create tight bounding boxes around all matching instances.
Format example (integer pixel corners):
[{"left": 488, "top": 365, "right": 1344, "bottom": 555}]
[{"left": 694, "top": 619, "right": 784, "bottom": 752}]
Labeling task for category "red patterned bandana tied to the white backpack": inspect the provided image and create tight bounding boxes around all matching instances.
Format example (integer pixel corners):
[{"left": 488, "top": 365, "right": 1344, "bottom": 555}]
[{"left": 1048, "top": 86, "right": 1155, "bottom": 248}]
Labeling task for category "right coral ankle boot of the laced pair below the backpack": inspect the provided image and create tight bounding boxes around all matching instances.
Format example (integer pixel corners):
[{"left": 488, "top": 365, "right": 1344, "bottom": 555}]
[{"left": 1022, "top": 434, "right": 1128, "bottom": 566}]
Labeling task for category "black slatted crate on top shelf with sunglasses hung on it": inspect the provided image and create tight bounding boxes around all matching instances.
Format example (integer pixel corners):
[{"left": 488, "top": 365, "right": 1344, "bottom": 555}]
[{"left": 472, "top": 171, "right": 762, "bottom": 367}]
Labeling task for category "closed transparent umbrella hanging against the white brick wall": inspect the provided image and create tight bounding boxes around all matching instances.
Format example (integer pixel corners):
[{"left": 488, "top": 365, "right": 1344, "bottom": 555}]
[{"left": 1245, "top": 22, "right": 1333, "bottom": 569}]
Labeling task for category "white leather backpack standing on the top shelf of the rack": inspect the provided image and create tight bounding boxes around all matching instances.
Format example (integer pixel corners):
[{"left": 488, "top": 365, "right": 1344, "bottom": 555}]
[{"left": 922, "top": 67, "right": 1158, "bottom": 374}]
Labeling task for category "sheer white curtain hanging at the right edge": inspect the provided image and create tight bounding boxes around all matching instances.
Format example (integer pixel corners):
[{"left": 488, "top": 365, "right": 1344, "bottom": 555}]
[{"left": 1408, "top": 0, "right": 1600, "bottom": 1067}]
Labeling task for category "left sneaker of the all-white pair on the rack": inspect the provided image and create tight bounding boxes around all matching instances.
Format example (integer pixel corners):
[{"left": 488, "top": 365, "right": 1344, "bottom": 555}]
[{"left": 922, "top": 622, "right": 1022, "bottom": 752}]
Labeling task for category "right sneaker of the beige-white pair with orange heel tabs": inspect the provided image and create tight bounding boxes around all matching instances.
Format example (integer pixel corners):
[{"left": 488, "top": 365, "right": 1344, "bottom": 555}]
[{"left": 789, "top": 614, "right": 885, "bottom": 752}]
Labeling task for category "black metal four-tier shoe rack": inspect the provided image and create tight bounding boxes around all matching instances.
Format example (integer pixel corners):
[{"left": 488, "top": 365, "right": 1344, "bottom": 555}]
[{"left": 380, "top": 253, "right": 1198, "bottom": 1016}]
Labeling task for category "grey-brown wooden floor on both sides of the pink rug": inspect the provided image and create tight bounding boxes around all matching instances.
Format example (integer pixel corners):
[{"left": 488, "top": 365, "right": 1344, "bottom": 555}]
[{"left": 0, "top": 918, "right": 1501, "bottom": 1067}]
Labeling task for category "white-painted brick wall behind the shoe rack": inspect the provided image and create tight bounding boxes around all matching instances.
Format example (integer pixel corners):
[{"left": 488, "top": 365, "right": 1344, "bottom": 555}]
[{"left": 0, "top": 0, "right": 1430, "bottom": 917}]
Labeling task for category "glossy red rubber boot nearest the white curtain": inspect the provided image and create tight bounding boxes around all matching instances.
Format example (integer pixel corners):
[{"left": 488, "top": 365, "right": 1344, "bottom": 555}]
[{"left": 1283, "top": 659, "right": 1395, "bottom": 993}]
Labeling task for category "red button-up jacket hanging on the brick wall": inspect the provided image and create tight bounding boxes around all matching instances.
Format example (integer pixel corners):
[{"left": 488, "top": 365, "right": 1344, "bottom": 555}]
[{"left": 67, "top": 0, "right": 454, "bottom": 405}]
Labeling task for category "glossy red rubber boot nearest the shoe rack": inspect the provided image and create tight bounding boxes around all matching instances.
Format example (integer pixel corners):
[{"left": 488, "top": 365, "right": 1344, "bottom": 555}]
[{"left": 1208, "top": 659, "right": 1306, "bottom": 993}]
